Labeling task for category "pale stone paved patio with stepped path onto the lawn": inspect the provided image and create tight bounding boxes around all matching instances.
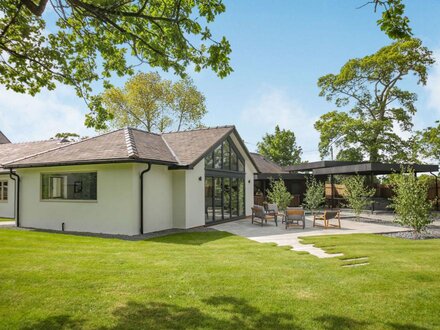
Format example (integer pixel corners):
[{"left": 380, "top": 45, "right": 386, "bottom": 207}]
[{"left": 212, "top": 215, "right": 408, "bottom": 258}]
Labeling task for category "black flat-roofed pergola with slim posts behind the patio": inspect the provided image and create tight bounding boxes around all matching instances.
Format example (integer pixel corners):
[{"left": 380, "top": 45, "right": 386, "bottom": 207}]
[{"left": 286, "top": 161, "right": 439, "bottom": 210}]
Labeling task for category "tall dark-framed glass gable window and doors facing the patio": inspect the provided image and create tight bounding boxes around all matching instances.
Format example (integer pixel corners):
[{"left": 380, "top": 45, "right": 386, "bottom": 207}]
[{"left": 205, "top": 138, "right": 245, "bottom": 223}]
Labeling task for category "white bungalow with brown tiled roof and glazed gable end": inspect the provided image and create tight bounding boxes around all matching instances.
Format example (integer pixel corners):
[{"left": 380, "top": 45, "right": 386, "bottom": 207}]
[{"left": 0, "top": 126, "right": 258, "bottom": 235}]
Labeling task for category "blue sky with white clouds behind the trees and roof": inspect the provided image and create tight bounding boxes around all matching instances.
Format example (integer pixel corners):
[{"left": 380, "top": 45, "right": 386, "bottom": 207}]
[{"left": 0, "top": 0, "right": 440, "bottom": 161}]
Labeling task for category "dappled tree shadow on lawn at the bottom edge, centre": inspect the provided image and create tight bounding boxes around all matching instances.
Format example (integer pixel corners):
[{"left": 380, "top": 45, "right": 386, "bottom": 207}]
[{"left": 103, "top": 297, "right": 302, "bottom": 330}]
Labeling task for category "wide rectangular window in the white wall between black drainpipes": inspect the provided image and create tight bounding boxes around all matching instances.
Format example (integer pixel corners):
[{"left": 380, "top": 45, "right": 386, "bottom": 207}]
[{"left": 41, "top": 172, "right": 97, "bottom": 201}]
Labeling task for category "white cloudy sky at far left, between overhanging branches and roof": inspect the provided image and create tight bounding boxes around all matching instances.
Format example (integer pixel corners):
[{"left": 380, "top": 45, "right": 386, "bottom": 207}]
[{"left": 0, "top": 86, "right": 95, "bottom": 142}]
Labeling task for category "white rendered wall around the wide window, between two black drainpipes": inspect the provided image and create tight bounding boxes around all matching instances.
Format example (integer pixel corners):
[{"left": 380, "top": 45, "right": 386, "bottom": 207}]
[{"left": 17, "top": 164, "right": 139, "bottom": 235}]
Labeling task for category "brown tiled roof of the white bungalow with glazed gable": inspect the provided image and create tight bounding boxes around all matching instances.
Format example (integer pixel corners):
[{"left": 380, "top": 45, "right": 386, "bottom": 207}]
[{"left": 0, "top": 126, "right": 255, "bottom": 168}]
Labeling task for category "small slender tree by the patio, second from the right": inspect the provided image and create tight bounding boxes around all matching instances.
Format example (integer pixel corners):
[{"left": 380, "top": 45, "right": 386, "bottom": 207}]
[{"left": 342, "top": 175, "right": 376, "bottom": 219}]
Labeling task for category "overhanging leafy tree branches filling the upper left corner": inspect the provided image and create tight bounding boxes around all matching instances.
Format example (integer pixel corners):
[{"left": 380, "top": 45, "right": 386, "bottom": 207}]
[{"left": 0, "top": 0, "right": 232, "bottom": 129}]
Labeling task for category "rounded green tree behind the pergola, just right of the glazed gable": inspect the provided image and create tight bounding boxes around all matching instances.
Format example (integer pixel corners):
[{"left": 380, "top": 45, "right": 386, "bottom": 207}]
[{"left": 257, "top": 125, "right": 302, "bottom": 166}]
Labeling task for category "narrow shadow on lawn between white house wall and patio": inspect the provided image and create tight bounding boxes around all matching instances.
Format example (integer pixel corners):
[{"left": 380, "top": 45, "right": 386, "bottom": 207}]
[{"left": 145, "top": 231, "right": 234, "bottom": 245}]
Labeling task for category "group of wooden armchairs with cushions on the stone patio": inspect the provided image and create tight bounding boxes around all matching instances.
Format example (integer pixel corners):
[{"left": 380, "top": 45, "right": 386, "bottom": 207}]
[{"left": 252, "top": 204, "right": 341, "bottom": 229}]
